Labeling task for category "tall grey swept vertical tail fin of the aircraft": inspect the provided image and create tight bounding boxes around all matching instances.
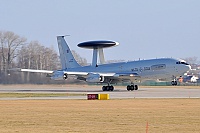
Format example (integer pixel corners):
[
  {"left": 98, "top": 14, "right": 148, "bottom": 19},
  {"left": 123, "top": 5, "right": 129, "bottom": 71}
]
[{"left": 57, "top": 36, "right": 80, "bottom": 69}]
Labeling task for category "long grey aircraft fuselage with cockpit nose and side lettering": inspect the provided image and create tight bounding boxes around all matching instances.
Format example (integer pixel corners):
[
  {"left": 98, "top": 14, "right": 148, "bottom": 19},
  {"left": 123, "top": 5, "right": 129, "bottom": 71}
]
[{"left": 66, "top": 58, "right": 190, "bottom": 80}]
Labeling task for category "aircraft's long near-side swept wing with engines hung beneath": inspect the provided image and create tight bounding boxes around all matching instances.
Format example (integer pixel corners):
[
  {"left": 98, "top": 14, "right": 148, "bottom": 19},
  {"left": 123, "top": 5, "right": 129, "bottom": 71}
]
[{"left": 9, "top": 68, "right": 140, "bottom": 82}]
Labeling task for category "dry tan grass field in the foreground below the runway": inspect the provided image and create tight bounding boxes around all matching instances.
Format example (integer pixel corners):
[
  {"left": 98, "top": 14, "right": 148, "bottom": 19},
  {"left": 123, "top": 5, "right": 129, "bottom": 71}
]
[{"left": 0, "top": 99, "right": 200, "bottom": 133}]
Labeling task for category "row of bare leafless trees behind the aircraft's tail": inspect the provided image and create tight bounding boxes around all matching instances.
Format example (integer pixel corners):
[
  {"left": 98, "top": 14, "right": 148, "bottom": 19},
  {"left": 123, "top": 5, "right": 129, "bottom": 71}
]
[{"left": 0, "top": 31, "right": 87, "bottom": 84}]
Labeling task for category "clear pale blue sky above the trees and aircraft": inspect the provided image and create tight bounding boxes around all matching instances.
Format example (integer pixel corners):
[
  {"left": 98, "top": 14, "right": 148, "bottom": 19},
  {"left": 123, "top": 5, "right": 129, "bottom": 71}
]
[{"left": 0, "top": 0, "right": 200, "bottom": 62}]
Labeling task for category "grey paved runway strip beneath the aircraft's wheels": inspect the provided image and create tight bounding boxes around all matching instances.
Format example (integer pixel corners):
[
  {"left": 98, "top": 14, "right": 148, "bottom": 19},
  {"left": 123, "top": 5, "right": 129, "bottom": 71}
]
[{"left": 0, "top": 85, "right": 200, "bottom": 100}]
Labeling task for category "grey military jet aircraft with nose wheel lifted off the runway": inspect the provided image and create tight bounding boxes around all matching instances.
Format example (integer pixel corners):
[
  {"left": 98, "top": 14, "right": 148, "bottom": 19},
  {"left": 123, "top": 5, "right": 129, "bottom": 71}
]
[{"left": 17, "top": 36, "right": 191, "bottom": 91}]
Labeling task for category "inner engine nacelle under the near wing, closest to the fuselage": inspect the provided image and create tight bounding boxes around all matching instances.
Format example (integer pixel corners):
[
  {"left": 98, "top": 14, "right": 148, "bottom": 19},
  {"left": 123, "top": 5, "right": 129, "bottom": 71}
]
[{"left": 86, "top": 74, "right": 104, "bottom": 83}]
